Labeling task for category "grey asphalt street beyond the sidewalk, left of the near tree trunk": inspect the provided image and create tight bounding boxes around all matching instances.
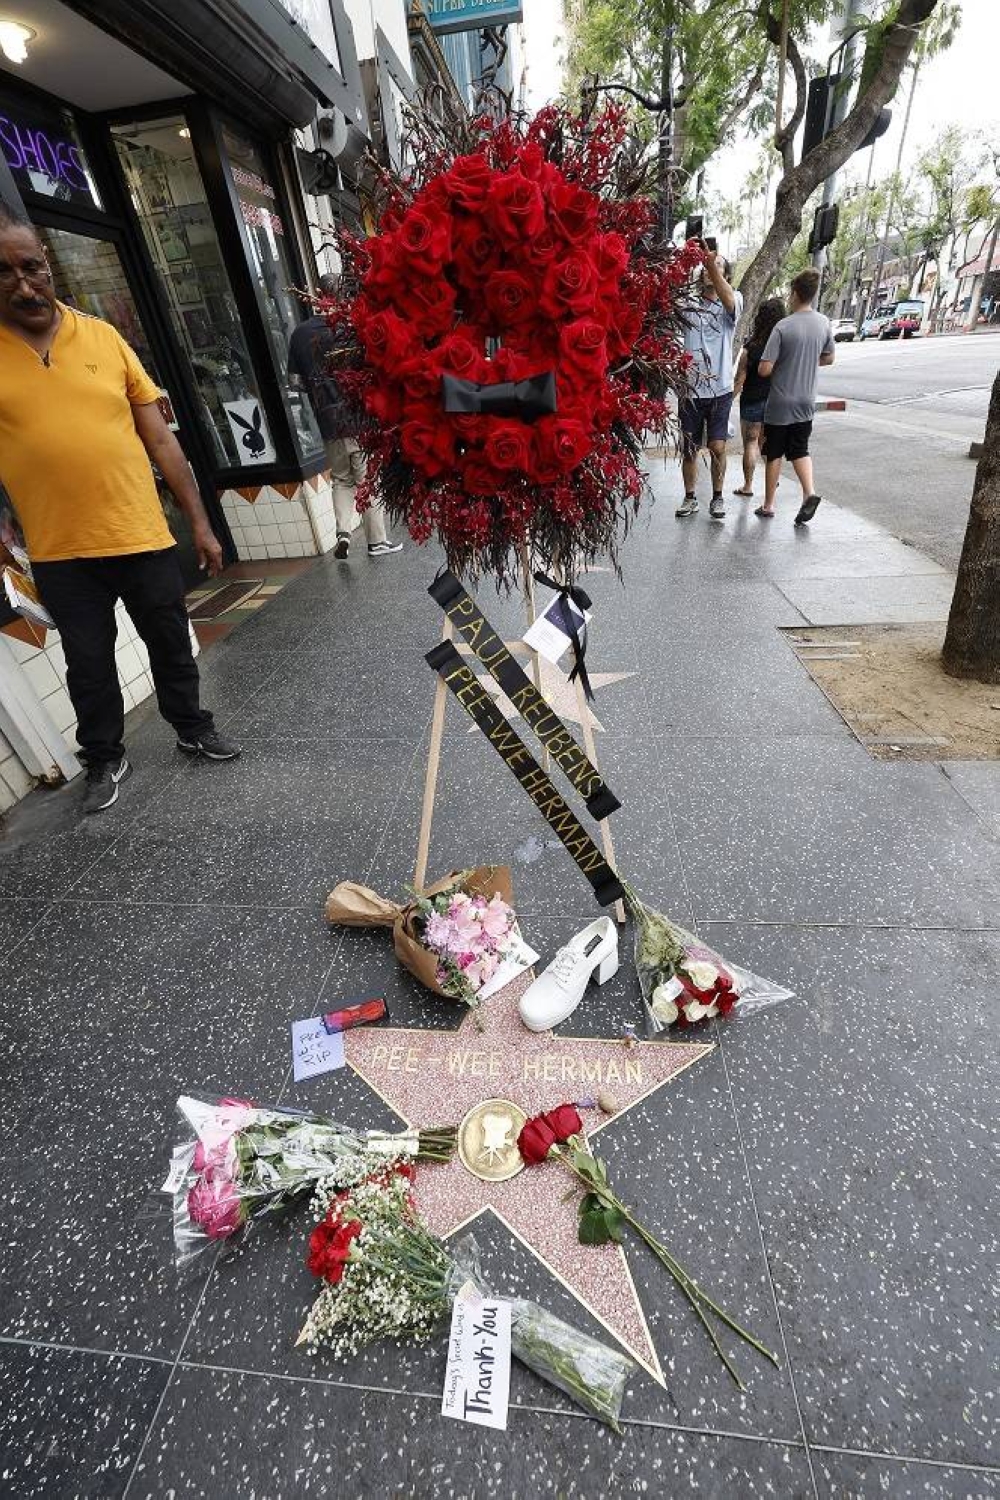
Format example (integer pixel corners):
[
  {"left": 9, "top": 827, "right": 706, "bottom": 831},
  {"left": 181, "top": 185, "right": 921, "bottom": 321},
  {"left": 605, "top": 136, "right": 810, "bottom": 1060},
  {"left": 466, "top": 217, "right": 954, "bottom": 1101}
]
[{"left": 815, "top": 335, "right": 1000, "bottom": 569}]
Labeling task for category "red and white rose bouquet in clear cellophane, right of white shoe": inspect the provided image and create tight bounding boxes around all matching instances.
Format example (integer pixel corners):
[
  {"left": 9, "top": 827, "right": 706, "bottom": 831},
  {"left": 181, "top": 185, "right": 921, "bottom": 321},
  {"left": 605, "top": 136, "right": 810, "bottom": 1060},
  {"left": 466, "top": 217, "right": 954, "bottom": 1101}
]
[{"left": 625, "top": 885, "right": 795, "bottom": 1037}]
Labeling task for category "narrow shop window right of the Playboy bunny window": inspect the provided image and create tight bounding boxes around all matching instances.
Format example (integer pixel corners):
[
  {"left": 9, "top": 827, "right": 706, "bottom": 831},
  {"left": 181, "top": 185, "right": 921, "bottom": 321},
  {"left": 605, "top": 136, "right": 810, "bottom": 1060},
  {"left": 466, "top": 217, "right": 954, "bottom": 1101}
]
[{"left": 222, "top": 126, "right": 322, "bottom": 458}]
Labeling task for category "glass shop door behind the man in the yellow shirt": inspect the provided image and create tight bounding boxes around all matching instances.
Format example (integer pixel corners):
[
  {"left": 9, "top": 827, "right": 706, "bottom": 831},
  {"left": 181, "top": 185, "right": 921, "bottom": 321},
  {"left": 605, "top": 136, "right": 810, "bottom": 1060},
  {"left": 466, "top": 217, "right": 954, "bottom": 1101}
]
[{"left": 37, "top": 225, "right": 201, "bottom": 585}]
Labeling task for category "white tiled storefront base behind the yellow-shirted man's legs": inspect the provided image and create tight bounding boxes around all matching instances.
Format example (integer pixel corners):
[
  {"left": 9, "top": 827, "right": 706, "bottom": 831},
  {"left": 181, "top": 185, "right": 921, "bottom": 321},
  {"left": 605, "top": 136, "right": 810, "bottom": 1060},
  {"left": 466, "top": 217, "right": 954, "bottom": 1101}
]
[{"left": 0, "top": 605, "right": 199, "bottom": 812}]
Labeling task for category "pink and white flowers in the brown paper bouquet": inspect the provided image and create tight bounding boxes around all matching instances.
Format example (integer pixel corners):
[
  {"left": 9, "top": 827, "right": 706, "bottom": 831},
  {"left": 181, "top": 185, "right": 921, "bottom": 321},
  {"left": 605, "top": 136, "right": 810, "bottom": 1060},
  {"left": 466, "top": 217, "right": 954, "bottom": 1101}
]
[{"left": 414, "top": 882, "right": 520, "bottom": 1005}]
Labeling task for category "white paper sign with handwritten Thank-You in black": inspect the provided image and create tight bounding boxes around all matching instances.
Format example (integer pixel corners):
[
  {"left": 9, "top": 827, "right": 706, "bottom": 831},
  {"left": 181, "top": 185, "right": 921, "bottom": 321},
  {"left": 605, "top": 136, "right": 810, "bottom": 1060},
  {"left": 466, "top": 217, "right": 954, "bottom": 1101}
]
[{"left": 441, "top": 1281, "right": 511, "bottom": 1430}]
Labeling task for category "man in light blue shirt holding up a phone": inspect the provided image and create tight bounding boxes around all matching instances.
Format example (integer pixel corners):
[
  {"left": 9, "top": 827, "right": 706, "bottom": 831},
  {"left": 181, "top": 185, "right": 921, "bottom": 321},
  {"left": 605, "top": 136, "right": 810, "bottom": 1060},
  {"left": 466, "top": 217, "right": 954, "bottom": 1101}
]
[{"left": 676, "top": 251, "right": 744, "bottom": 521}]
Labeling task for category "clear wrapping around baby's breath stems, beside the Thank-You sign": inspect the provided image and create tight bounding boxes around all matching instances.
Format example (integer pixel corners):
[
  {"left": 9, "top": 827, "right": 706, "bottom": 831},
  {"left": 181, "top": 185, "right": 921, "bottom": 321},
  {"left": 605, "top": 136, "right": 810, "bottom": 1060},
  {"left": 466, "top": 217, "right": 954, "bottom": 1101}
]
[{"left": 448, "top": 1235, "right": 634, "bottom": 1433}]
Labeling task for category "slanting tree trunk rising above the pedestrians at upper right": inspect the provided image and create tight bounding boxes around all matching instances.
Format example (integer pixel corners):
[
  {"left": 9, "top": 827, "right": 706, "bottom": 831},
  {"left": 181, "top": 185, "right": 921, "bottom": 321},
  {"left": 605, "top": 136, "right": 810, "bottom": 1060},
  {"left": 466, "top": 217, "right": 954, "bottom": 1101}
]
[{"left": 739, "top": 0, "right": 937, "bottom": 327}]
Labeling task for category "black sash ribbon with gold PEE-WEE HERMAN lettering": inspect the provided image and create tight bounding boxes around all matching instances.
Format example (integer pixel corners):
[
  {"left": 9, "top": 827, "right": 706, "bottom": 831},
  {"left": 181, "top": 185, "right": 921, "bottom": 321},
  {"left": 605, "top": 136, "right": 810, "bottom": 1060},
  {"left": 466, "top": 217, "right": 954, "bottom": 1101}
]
[{"left": 426, "top": 641, "right": 624, "bottom": 906}]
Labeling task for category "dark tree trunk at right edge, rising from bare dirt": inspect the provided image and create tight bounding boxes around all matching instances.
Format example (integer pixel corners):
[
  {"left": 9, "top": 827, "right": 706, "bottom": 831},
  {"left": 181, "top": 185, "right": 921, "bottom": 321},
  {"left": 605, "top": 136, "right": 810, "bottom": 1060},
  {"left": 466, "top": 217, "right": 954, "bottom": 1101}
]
[{"left": 942, "top": 375, "right": 1000, "bottom": 683}]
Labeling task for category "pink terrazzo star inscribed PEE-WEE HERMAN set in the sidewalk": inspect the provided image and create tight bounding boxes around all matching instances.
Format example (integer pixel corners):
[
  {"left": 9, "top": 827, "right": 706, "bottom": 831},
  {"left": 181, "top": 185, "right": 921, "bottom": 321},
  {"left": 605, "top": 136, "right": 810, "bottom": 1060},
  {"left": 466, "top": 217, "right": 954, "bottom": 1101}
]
[{"left": 345, "top": 974, "right": 712, "bottom": 1385}]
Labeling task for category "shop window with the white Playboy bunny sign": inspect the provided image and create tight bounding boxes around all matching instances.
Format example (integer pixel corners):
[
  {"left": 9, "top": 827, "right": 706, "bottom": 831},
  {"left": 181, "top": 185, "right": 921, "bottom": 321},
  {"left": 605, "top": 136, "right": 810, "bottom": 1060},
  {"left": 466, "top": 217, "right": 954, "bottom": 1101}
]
[{"left": 111, "top": 116, "right": 276, "bottom": 468}]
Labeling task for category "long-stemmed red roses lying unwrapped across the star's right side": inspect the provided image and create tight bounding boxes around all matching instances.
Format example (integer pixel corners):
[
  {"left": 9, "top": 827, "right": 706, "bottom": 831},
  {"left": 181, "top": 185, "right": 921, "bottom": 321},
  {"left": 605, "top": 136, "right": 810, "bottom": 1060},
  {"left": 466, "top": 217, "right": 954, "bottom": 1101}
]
[{"left": 517, "top": 1104, "right": 778, "bottom": 1391}]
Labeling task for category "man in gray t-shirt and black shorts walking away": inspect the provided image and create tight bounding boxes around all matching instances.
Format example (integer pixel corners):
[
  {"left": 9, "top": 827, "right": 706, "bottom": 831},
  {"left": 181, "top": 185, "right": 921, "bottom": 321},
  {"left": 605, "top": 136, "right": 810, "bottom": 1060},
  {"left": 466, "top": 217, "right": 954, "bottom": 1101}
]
[{"left": 754, "top": 269, "right": 834, "bottom": 527}]
